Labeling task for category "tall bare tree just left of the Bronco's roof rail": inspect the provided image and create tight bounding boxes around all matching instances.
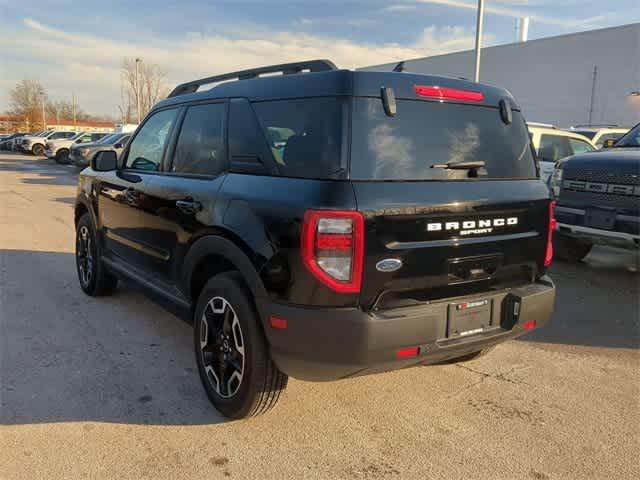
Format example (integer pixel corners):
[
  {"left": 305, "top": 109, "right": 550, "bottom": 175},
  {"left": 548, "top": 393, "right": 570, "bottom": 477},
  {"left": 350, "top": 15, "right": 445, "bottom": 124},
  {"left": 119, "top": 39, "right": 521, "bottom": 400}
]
[{"left": 118, "top": 57, "right": 169, "bottom": 123}]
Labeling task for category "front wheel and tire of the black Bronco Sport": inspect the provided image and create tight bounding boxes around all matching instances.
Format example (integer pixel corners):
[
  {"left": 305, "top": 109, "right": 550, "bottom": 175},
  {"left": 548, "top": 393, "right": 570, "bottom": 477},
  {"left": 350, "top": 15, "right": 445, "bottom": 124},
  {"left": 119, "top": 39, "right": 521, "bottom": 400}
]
[{"left": 76, "top": 213, "right": 118, "bottom": 297}]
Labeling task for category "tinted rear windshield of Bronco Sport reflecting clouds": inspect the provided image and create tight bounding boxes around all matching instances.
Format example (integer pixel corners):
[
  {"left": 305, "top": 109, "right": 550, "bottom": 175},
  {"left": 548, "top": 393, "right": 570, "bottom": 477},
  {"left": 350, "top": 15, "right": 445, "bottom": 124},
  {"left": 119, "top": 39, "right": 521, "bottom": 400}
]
[{"left": 351, "top": 98, "right": 537, "bottom": 180}]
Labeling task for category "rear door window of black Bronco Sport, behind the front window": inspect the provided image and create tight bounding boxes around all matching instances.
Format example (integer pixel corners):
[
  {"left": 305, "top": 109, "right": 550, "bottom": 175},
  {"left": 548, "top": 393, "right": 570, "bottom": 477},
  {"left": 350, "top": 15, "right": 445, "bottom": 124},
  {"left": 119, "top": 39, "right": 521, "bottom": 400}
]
[{"left": 171, "top": 103, "right": 227, "bottom": 175}]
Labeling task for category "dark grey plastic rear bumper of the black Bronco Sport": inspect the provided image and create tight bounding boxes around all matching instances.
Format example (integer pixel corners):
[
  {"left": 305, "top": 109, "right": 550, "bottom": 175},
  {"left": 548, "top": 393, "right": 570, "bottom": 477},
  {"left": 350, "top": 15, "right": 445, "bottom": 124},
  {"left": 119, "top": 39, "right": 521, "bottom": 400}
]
[{"left": 267, "top": 277, "right": 555, "bottom": 381}]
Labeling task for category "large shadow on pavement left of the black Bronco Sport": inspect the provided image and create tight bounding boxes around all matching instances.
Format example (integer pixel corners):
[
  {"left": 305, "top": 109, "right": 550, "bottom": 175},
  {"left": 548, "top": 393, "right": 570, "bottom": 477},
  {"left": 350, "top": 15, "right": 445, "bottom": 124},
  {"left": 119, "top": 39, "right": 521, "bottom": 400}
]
[{"left": 0, "top": 250, "right": 225, "bottom": 425}]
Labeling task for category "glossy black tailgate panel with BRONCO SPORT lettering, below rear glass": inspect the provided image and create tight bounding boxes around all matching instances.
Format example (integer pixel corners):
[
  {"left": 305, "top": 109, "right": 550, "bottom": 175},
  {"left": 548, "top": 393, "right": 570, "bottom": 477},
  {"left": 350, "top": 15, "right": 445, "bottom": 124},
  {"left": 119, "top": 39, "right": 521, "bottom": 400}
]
[{"left": 353, "top": 180, "right": 549, "bottom": 309}]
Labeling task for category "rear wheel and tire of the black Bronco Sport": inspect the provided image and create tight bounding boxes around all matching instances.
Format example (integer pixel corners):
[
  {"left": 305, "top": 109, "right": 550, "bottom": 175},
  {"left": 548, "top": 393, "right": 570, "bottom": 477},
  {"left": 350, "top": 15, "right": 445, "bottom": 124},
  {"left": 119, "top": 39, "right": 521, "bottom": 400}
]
[{"left": 193, "top": 272, "right": 288, "bottom": 419}]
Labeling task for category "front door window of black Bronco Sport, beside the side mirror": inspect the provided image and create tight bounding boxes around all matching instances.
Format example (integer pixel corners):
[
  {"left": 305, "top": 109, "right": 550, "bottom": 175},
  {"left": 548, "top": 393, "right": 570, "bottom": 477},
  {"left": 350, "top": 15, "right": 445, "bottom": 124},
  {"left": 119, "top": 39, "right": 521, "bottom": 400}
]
[{"left": 125, "top": 109, "right": 178, "bottom": 172}]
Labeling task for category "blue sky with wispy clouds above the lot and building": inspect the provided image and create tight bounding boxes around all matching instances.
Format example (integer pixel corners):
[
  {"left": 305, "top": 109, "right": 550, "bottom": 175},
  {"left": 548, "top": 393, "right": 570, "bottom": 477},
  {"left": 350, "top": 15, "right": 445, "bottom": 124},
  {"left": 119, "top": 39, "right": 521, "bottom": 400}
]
[{"left": 0, "top": 0, "right": 640, "bottom": 116}]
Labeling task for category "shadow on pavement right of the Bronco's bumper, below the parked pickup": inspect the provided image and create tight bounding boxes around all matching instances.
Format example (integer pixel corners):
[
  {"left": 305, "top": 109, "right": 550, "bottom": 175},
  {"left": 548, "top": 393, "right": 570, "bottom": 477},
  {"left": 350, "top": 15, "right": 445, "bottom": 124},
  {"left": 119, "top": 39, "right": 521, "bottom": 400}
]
[{"left": 521, "top": 246, "right": 640, "bottom": 349}]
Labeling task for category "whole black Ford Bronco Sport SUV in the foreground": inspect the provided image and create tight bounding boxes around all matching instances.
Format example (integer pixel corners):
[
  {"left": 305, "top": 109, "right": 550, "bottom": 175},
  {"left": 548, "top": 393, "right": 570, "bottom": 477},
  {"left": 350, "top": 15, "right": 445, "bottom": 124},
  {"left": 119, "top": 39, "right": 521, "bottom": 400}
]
[{"left": 75, "top": 60, "right": 555, "bottom": 418}]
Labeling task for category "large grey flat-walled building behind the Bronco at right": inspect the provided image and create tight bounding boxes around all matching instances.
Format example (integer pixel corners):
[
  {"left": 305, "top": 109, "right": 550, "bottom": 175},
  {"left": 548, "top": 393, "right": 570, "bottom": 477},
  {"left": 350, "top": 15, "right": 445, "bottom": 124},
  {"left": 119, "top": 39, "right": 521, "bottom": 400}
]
[{"left": 364, "top": 23, "right": 640, "bottom": 127}]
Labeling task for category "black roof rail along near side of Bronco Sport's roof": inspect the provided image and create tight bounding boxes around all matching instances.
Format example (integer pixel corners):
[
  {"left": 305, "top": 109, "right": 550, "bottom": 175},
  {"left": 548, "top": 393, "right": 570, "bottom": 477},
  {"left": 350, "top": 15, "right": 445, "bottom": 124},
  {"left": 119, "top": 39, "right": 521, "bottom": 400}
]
[{"left": 167, "top": 60, "right": 338, "bottom": 98}]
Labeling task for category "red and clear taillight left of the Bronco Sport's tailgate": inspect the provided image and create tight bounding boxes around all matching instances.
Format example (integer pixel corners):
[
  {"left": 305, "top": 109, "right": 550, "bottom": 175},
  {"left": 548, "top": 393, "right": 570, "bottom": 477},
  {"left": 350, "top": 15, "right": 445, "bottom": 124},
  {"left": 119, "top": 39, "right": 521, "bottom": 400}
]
[{"left": 301, "top": 210, "right": 364, "bottom": 293}]
